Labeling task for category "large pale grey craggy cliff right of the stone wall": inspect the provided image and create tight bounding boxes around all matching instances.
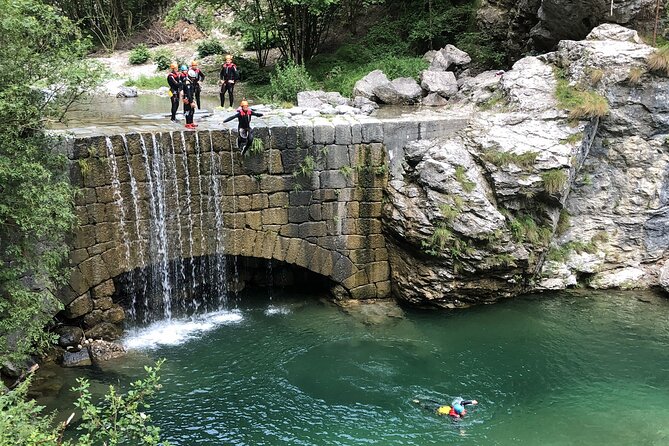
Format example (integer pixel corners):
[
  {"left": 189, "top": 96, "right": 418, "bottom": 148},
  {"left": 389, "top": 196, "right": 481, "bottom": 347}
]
[{"left": 384, "top": 26, "right": 669, "bottom": 307}]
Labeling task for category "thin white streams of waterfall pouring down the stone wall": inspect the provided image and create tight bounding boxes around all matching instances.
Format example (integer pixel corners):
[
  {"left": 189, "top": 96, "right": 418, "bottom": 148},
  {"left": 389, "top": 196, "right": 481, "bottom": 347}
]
[{"left": 111, "top": 132, "right": 237, "bottom": 324}]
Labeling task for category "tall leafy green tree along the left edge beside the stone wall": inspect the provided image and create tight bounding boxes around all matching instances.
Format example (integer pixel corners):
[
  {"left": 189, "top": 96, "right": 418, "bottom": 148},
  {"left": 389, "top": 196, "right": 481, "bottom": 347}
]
[{"left": 0, "top": 0, "right": 102, "bottom": 361}]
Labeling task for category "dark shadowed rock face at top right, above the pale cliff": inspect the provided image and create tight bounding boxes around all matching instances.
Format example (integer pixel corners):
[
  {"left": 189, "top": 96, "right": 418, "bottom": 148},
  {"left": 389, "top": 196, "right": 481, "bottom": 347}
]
[{"left": 478, "top": 0, "right": 663, "bottom": 60}]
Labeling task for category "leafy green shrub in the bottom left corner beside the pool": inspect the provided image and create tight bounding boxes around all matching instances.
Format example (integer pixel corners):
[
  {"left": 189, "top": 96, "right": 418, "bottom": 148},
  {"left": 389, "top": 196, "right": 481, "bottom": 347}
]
[{"left": 0, "top": 360, "right": 169, "bottom": 446}]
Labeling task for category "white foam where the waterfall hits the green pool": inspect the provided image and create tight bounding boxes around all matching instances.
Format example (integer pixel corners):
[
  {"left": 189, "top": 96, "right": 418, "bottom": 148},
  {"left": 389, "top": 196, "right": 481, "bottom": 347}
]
[{"left": 123, "top": 311, "right": 243, "bottom": 350}]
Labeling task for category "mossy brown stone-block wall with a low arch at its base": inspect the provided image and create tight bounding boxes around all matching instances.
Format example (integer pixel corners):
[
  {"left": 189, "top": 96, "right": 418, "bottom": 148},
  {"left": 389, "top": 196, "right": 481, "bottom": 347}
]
[{"left": 60, "top": 115, "right": 464, "bottom": 336}]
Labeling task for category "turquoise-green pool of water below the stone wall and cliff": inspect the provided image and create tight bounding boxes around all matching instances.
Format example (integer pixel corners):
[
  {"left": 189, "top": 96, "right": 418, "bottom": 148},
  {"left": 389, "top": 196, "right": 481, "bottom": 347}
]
[{"left": 37, "top": 293, "right": 669, "bottom": 445}]
